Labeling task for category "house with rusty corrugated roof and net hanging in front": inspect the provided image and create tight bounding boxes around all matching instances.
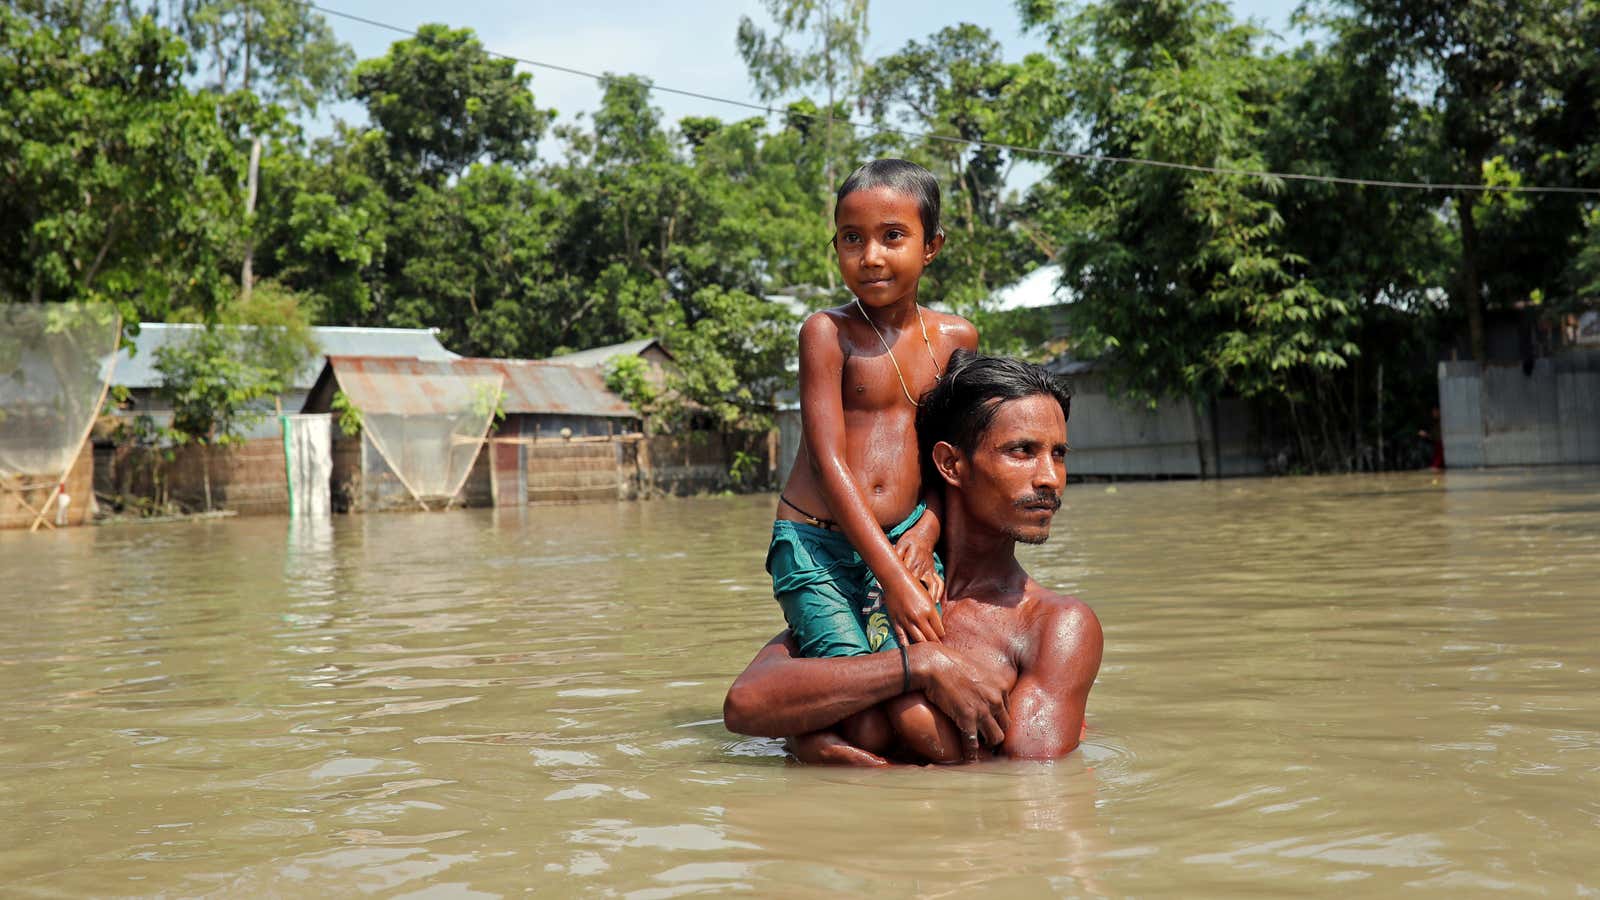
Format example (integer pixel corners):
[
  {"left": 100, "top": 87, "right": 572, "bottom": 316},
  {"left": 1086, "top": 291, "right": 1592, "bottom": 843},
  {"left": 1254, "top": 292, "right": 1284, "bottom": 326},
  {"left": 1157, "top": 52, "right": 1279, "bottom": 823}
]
[{"left": 302, "top": 356, "right": 640, "bottom": 511}]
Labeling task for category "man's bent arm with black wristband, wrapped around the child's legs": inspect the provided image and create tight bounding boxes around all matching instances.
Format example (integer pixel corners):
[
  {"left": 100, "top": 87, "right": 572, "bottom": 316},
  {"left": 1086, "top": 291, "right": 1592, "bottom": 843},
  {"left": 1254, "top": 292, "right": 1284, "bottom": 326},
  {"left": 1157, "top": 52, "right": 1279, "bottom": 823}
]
[{"left": 722, "top": 631, "right": 1010, "bottom": 743}]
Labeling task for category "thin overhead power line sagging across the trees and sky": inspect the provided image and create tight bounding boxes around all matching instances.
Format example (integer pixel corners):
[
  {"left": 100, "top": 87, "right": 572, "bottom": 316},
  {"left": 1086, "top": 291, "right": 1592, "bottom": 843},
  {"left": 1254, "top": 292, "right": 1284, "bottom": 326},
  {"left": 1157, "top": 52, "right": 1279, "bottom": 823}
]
[{"left": 306, "top": 2, "right": 1600, "bottom": 197}]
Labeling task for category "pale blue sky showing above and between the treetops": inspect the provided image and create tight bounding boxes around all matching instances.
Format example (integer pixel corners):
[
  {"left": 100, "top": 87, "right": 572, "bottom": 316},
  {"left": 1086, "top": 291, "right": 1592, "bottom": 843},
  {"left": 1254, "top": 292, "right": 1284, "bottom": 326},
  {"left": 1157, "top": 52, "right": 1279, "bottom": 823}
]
[{"left": 312, "top": 0, "right": 1298, "bottom": 139}]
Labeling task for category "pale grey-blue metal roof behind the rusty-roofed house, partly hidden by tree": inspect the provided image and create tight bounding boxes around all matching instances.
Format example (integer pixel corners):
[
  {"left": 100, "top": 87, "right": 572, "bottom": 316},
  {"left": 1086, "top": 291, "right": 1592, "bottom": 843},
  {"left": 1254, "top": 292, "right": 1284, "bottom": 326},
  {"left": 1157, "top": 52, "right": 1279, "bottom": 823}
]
[{"left": 112, "top": 322, "right": 461, "bottom": 391}]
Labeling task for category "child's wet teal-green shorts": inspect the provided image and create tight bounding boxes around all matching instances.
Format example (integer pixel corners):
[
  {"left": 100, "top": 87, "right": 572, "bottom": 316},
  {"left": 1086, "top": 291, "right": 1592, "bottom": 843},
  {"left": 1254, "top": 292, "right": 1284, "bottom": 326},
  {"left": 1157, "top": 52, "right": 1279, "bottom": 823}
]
[{"left": 766, "top": 503, "right": 944, "bottom": 658}]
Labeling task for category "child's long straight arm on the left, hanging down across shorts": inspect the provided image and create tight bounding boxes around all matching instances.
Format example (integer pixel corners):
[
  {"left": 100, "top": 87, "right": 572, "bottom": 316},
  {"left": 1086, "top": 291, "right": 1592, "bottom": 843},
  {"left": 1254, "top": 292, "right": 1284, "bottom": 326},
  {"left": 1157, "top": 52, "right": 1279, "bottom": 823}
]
[{"left": 800, "top": 312, "right": 944, "bottom": 641}]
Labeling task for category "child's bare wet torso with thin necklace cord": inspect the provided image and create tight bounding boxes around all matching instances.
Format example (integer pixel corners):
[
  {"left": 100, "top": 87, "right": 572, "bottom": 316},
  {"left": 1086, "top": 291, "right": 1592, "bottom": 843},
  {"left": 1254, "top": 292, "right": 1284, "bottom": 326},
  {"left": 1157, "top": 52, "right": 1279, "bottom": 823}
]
[{"left": 778, "top": 304, "right": 976, "bottom": 528}]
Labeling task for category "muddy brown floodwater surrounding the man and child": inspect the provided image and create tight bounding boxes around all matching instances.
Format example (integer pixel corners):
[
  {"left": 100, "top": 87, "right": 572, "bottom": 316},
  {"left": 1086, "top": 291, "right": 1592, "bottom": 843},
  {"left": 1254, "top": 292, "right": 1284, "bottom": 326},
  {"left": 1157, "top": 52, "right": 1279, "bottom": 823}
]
[{"left": 0, "top": 469, "right": 1600, "bottom": 898}]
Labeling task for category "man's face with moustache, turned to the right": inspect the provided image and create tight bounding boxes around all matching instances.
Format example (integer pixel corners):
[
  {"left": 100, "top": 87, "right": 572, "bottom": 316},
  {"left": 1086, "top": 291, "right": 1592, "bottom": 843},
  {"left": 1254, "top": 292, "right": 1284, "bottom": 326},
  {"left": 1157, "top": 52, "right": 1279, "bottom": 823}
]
[{"left": 960, "top": 394, "right": 1067, "bottom": 544}]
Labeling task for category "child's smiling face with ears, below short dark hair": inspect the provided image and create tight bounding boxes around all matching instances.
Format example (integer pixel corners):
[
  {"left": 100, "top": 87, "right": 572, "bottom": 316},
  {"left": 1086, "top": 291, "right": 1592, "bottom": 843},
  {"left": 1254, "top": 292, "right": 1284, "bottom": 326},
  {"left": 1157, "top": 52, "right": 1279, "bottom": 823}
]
[{"left": 834, "top": 187, "right": 944, "bottom": 307}]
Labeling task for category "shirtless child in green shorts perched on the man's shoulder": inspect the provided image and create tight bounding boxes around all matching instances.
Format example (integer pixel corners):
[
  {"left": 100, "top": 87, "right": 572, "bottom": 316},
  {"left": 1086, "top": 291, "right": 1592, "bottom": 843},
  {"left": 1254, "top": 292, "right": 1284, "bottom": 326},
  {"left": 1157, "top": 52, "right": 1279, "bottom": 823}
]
[{"left": 766, "top": 160, "right": 978, "bottom": 762}]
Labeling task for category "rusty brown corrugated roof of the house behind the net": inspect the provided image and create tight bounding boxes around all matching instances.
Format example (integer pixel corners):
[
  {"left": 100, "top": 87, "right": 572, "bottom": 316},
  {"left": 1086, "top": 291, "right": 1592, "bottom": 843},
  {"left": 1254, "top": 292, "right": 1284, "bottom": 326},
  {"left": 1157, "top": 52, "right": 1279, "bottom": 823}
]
[{"left": 328, "top": 356, "right": 638, "bottom": 418}]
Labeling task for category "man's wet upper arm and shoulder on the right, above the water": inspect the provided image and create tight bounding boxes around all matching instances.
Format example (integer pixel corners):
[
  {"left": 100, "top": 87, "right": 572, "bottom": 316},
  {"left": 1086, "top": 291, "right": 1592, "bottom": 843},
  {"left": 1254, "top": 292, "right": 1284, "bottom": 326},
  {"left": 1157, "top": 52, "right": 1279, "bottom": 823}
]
[{"left": 1000, "top": 601, "right": 1104, "bottom": 759}]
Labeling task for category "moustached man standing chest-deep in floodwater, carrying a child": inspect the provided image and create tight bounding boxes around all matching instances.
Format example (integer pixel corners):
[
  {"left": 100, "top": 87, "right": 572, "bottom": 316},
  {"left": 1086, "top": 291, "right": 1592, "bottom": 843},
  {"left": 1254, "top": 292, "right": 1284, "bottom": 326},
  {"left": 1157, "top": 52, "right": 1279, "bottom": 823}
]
[{"left": 723, "top": 352, "right": 1102, "bottom": 765}]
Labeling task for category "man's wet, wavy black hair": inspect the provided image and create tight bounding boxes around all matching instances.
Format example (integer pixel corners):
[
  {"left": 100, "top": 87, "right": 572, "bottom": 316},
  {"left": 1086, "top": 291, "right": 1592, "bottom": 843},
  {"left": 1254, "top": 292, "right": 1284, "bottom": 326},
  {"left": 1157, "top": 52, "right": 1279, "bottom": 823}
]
[{"left": 917, "top": 349, "right": 1072, "bottom": 484}]
